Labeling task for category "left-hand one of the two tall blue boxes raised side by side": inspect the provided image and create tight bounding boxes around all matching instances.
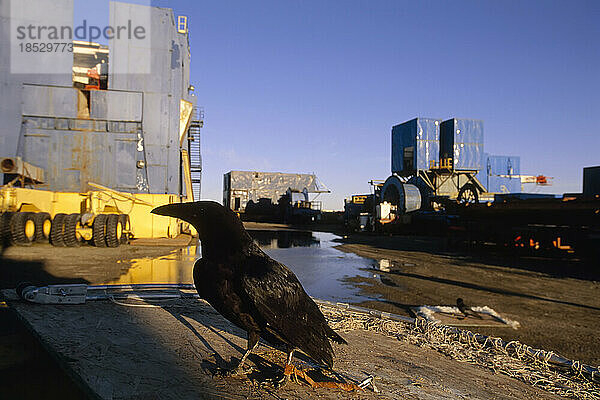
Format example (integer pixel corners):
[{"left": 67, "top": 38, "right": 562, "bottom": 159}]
[{"left": 392, "top": 118, "right": 442, "bottom": 176}]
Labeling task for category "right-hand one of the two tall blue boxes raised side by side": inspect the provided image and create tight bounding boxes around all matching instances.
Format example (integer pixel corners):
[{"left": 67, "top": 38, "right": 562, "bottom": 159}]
[{"left": 440, "top": 118, "right": 483, "bottom": 171}]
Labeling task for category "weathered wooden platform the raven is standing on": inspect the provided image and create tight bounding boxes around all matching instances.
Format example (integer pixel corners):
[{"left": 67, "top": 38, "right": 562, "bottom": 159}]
[{"left": 3, "top": 290, "right": 556, "bottom": 400}]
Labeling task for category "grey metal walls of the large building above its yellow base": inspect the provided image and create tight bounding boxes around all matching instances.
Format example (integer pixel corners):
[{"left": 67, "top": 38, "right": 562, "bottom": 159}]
[{"left": 0, "top": 0, "right": 196, "bottom": 195}]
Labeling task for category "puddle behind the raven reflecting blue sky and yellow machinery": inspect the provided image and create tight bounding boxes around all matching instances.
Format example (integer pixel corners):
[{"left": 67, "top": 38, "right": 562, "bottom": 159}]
[{"left": 106, "top": 231, "right": 373, "bottom": 302}]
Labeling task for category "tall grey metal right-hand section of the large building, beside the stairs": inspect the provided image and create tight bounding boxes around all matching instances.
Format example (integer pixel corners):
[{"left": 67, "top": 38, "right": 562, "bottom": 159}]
[{"left": 109, "top": 2, "right": 196, "bottom": 194}]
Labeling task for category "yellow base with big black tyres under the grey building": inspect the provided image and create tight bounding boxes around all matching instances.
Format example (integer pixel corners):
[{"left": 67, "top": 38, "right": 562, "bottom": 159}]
[{"left": 0, "top": 183, "right": 189, "bottom": 247}]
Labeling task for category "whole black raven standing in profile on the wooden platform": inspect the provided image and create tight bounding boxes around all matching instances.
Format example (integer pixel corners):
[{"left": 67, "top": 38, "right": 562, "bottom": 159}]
[{"left": 152, "top": 201, "right": 347, "bottom": 377}]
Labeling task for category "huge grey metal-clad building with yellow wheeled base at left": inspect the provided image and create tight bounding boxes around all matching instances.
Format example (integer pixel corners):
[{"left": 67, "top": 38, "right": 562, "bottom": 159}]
[{"left": 0, "top": 0, "right": 202, "bottom": 245}]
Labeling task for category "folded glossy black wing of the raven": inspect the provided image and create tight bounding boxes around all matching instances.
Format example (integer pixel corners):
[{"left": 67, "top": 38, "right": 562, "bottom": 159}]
[{"left": 241, "top": 254, "right": 345, "bottom": 367}]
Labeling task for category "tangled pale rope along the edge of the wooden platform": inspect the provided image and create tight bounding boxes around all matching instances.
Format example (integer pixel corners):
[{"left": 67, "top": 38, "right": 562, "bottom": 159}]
[{"left": 319, "top": 304, "right": 600, "bottom": 400}]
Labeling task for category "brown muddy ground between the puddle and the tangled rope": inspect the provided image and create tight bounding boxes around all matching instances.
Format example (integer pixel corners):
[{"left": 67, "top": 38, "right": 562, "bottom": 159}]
[{"left": 337, "top": 235, "right": 600, "bottom": 366}]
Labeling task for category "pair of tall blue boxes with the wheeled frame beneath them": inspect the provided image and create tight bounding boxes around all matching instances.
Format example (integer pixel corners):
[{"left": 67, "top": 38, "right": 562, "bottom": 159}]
[{"left": 381, "top": 118, "right": 485, "bottom": 212}]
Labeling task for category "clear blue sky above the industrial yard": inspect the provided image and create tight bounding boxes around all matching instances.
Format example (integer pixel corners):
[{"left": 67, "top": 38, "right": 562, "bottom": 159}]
[{"left": 97, "top": 0, "right": 600, "bottom": 209}]
